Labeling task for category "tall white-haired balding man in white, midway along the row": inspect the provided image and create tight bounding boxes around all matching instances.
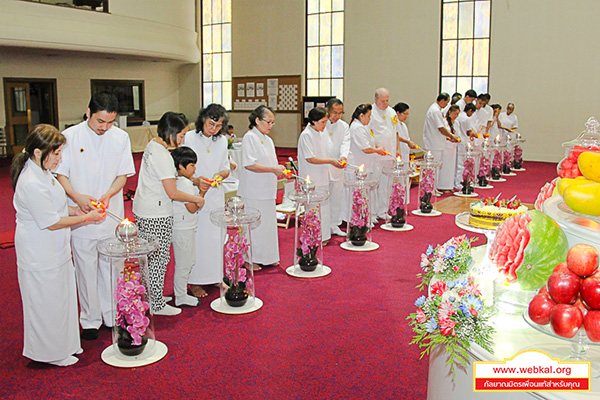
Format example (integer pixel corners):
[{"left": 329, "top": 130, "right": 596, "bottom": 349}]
[{"left": 369, "top": 88, "right": 399, "bottom": 219}]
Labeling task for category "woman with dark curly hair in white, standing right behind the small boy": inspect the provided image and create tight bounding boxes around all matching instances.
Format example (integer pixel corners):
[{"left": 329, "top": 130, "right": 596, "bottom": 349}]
[{"left": 183, "top": 104, "right": 230, "bottom": 297}]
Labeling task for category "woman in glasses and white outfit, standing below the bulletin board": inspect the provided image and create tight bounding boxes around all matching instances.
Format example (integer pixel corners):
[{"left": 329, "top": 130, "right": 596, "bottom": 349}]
[{"left": 238, "top": 106, "right": 286, "bottom": 270}]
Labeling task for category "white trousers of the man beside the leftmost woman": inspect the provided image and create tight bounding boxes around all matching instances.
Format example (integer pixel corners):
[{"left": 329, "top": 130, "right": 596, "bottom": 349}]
[{"left": 71, "top": 236, "right": 117, "bottom": 329}]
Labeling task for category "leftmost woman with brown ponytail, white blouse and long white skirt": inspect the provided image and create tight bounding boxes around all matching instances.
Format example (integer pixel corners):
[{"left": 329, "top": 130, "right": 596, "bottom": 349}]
[{"left": 11, "top": 124, "right": 105, "bottom": 366}]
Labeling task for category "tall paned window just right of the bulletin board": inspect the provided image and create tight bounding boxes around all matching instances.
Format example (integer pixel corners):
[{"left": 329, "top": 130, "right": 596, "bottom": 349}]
[{"left": 306, "top": 0, "right": 344, "bottom": 99}]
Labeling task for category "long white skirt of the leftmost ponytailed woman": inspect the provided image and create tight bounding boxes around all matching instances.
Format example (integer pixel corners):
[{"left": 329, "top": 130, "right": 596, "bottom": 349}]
[{"left": 17, "top": 260, "right": 81, "bottom": 362}]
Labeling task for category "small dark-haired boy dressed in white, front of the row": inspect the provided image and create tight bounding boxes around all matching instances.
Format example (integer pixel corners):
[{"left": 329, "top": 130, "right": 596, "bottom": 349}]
[{"left": 171, "top": 146, "right": 206, "bottom": 307}]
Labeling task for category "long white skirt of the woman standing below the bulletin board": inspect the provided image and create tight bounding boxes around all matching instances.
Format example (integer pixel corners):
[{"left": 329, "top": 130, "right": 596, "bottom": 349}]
[{"left": 242, "top": 197, "right": 279, "bottom": 265}]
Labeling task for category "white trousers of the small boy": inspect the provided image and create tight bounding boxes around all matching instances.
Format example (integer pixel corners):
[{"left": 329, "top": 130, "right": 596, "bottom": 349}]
[{"left": 171, "top": 229, "right": 196, "bottom": 297}]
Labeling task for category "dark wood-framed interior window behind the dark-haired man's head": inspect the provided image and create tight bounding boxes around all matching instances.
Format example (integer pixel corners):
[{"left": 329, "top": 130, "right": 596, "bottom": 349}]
[{"left": 91, "top": 79, "right": 146, "bottom": 122}]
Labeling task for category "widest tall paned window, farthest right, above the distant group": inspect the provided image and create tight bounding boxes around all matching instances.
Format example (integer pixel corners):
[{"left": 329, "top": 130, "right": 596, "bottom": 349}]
[{"left": 440, "top": 0, "right": 491, "bottom": 94}]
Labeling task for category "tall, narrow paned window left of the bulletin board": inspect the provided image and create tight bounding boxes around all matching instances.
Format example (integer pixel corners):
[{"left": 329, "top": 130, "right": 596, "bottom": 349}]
[{"left": 202, "top": 0, "right": 231, "bottom": 110}]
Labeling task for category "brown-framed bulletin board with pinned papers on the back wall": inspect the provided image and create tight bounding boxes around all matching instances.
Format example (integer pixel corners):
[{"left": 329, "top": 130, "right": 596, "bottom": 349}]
[{"left": 232, "top": 75, "right": 302, "bottom": 113}]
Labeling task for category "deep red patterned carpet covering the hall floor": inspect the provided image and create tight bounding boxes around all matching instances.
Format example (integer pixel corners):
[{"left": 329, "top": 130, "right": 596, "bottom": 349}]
[{"left": 0, "top": 158, "right": 556, "bottom": 399}]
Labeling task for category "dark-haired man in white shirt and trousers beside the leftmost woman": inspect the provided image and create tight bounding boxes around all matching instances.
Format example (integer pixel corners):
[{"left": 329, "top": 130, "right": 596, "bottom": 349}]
[{"left": 55, "top": 92, "right": 135, "bottom": 340}]
